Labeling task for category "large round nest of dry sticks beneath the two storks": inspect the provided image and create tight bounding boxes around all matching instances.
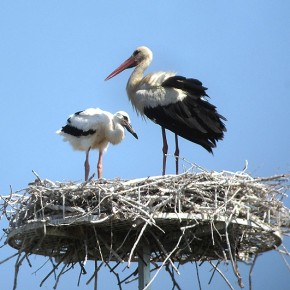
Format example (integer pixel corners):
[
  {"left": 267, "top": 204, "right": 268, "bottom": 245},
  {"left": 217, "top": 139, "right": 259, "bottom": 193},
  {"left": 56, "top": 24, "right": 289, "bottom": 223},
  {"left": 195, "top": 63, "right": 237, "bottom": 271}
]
[{"left": 1, "top": 170, "right": 290, "bottom": 286}]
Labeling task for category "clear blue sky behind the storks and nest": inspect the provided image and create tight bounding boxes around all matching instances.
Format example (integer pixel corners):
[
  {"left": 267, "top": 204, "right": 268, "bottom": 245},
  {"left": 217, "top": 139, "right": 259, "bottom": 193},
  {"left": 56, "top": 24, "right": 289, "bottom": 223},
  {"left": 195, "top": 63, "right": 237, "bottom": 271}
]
[{"left": 0, "top": 0, "right": 290, "bottom": 290}]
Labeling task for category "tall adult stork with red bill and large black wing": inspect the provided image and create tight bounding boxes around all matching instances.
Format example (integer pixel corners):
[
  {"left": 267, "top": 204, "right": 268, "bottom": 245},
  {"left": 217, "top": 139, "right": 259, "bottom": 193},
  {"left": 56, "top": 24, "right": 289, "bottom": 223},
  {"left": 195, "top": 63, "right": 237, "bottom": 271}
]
[{"left": 105, "top": 46, "right": 226, "bottom": 175}]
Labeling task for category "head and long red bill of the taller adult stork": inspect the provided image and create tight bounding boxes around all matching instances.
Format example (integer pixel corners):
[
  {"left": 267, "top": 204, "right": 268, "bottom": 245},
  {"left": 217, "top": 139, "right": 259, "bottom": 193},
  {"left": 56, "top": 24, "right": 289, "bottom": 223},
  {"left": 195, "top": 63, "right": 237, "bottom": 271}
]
[{"left": 105, "top": 46, "right": 153, "bottom": 81}]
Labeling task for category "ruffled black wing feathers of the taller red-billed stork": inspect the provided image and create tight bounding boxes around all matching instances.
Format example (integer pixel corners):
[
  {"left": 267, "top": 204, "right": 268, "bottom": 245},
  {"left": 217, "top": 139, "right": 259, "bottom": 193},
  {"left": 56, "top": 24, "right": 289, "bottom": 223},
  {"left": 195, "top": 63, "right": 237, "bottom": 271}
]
[{"left": 144, "top": 76, "right": 226, "bottom": 152}]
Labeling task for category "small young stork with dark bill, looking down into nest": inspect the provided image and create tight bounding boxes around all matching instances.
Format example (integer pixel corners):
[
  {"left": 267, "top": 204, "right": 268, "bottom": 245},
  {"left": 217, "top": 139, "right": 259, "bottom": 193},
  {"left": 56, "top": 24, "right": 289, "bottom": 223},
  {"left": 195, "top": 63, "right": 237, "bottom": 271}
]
[{"left": 56, "top": 108, "right": 138, "bottom": 181}]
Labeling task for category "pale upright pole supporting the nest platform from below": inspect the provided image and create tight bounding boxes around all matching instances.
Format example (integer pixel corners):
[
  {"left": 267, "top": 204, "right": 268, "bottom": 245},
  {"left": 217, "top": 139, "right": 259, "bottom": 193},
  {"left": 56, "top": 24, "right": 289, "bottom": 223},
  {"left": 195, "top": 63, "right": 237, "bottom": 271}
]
[{"left": 138, "top": 245, "right": 151, "bottom": 290}]
